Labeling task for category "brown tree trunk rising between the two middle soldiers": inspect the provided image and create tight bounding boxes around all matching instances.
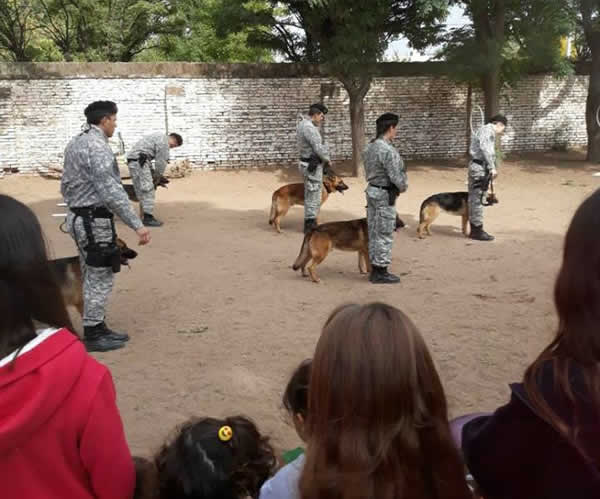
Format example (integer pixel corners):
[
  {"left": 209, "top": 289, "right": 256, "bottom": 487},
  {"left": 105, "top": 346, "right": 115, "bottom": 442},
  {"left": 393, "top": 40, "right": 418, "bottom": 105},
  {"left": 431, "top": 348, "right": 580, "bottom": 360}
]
[{"left": 340, "top": 77, "right": 371, "bottom": 177}]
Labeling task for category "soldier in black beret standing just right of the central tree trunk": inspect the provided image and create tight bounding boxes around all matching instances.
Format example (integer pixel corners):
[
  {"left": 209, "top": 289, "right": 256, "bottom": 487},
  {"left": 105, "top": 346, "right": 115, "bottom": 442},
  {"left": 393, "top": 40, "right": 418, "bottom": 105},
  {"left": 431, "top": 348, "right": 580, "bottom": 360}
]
[{"left": 364, "top": 113, "right": 408, "bottom": 284}]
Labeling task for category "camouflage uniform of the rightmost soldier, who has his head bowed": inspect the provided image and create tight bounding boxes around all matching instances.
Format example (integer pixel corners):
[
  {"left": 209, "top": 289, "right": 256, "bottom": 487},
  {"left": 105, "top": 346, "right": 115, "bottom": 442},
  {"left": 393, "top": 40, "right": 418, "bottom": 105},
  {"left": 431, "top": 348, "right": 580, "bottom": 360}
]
[{"left": 469, "top": 123, "right": 496, "bottom": 226}]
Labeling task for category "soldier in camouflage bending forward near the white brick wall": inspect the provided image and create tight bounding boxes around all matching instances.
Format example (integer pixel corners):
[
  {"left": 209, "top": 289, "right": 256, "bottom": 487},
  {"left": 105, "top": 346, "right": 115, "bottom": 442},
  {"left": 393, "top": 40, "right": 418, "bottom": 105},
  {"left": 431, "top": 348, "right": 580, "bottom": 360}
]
[{"left": 127, "top": 133, "right": 183, "bottom": 227}]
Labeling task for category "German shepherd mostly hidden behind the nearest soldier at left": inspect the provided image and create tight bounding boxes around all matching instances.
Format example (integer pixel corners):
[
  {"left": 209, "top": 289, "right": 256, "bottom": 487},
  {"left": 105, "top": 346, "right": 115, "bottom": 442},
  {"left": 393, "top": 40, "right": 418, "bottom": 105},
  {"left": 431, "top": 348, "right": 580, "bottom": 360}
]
[{"left": 48, "top": 238, "right": 137, "bottom": 315}]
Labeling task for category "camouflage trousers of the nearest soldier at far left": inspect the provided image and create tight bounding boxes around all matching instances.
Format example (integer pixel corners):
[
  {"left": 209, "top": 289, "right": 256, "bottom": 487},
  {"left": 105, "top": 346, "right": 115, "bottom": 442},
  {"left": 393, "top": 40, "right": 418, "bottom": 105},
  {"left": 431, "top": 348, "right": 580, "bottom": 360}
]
[{"left": 67, "top": 213, "right": 114, "bottom": 326}]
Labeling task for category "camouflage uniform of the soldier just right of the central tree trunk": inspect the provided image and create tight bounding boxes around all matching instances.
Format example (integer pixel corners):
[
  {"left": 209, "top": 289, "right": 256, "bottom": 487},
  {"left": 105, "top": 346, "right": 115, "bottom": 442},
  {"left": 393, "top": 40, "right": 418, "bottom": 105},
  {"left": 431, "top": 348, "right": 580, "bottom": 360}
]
[{"left": 364, "top": 138, "right": 408, "bottom": 267}]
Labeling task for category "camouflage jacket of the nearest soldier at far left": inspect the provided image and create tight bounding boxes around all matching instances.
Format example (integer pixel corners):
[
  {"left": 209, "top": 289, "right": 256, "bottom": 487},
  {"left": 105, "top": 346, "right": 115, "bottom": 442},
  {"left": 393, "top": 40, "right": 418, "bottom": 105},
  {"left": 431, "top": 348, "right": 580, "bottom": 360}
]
[{"left": 60, "top": 125, "right": 143, "bottom": 230}]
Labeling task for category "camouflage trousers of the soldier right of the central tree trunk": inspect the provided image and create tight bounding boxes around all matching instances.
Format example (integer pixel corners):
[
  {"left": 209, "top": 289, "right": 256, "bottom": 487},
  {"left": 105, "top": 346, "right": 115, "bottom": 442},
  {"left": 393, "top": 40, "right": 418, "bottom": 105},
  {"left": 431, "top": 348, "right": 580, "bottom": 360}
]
[{"left": 366, "top": 186, "right": 396, "bottom": 267}]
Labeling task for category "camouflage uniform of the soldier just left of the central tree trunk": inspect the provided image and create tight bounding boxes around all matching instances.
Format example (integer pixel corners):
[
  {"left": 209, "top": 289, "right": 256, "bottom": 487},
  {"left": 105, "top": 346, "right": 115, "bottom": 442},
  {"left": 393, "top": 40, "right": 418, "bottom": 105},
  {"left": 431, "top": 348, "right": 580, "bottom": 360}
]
[{"left": 296, "top": 118, "right": 329, "bottom": 220}]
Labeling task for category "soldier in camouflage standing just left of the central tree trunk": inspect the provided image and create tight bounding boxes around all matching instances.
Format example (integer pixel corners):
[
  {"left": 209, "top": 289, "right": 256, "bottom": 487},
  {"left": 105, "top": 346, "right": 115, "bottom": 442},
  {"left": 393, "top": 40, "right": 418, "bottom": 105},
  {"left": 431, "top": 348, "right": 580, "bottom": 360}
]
[{"left": 296, "top": 104, "right": 330, "bottom": 233}]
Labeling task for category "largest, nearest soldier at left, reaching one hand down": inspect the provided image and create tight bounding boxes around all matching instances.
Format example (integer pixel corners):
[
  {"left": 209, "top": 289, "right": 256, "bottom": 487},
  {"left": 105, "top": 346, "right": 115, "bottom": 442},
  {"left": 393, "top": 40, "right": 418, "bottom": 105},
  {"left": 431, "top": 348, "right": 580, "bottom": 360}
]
[{"left": 61, "top": 101, "right": 150, "bottom": 352}]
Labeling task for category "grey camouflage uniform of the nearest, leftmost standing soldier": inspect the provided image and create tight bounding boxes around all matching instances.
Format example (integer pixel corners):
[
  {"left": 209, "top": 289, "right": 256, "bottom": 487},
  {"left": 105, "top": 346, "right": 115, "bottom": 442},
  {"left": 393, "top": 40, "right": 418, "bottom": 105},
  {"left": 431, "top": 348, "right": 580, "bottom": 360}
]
[{"left": 61, "top": 125, "right": 143, "bottom": 326}]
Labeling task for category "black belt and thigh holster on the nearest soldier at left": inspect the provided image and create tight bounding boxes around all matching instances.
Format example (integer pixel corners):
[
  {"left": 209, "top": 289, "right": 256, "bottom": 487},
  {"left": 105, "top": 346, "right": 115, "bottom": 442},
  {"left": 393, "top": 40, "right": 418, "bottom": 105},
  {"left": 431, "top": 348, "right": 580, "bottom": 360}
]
[{"left": 70, "top": 206, "right": 121, "bottom": 274}]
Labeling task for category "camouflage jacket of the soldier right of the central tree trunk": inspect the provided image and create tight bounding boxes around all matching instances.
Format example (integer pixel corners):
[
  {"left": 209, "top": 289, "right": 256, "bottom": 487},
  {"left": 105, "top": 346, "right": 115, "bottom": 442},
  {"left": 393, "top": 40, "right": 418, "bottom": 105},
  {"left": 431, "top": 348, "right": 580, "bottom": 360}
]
[{"left": 363, "top": 138, "right": 408, "bottom": 192}]
